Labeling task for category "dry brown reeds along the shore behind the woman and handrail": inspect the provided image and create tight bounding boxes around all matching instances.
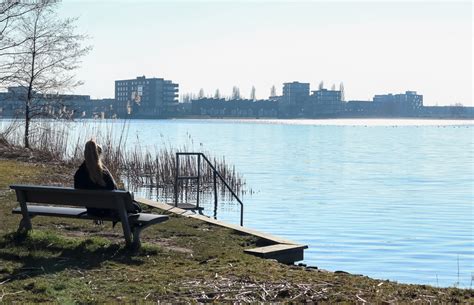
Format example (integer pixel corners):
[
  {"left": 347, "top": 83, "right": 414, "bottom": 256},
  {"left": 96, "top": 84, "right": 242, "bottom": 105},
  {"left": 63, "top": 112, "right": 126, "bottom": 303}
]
[{"left": 0, "top": 120, "right": 246, "bottom": 199}]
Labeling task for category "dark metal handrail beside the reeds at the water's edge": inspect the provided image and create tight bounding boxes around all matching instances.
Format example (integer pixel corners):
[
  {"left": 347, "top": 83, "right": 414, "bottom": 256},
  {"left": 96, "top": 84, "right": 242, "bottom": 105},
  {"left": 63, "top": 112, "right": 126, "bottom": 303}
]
[{"left": 174, "top": 152, "right": 244, "bottom": 226}]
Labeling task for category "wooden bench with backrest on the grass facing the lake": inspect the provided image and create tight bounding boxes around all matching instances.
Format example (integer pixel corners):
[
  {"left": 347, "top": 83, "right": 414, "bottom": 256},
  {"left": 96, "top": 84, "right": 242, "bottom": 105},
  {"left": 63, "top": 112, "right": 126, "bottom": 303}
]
[{"left": 10, "top": 185, "right": 169, "bottom": 249}]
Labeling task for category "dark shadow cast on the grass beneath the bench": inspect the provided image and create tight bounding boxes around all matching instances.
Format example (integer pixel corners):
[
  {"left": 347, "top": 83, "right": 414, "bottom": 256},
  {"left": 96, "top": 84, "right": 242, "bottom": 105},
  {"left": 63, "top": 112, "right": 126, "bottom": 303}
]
[{"left": 0, "top": 231, "right": 159, "bottom": 282}]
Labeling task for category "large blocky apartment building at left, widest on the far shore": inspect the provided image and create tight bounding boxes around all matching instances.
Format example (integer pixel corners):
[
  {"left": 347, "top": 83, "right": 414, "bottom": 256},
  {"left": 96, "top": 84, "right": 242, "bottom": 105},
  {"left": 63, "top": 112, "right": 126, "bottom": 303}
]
[{"left": 115, "top": 76, "right": 179, "bottom": 118}]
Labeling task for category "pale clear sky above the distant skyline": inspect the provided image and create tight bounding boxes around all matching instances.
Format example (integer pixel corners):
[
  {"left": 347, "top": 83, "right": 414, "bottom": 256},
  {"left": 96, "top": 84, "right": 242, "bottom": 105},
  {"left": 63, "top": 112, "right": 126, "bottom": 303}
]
[{"left": 59, "top": 0, "right": 474, "bottom": 106}]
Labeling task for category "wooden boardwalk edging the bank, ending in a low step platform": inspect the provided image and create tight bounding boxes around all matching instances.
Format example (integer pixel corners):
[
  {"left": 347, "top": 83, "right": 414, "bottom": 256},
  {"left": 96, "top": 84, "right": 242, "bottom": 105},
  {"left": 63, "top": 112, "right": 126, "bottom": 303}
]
[{"left": 135, "top": 198, "right": 308, "bottom": 264}]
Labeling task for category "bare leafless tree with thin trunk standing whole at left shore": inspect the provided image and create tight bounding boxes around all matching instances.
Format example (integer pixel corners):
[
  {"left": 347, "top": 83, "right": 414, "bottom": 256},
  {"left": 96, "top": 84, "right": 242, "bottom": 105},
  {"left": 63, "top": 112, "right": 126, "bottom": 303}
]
[{"left": 11, "top": 0, "right": 91, "bottom": 148}]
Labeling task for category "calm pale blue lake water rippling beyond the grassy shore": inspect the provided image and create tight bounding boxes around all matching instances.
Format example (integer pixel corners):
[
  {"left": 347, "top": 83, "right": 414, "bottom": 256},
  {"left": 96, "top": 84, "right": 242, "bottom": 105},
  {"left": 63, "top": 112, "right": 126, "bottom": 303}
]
[{"left": 4, "top": 120, "right": 474, "bottom": 288}]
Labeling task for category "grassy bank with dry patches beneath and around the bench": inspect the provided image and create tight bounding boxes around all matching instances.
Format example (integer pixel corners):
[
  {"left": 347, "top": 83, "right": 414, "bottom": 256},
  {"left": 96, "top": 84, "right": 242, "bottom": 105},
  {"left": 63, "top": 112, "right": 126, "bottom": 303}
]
[{"left": 0, "top": 160, "right": 474, "bottom": 304}]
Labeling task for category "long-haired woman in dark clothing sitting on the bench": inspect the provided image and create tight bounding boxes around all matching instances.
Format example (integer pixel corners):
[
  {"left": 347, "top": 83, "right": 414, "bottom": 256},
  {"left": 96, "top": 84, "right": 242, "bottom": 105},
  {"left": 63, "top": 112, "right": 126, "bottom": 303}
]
[{"left": 74, "top": 139, "right": 117, "bottom": 217}]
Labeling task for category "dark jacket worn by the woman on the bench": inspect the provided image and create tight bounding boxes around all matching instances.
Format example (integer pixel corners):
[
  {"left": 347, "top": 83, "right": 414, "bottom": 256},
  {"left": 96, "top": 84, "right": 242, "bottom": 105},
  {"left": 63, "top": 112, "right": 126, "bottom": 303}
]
[{"left": 74, "top": 162, "right": 117, "bottom": 217}]
